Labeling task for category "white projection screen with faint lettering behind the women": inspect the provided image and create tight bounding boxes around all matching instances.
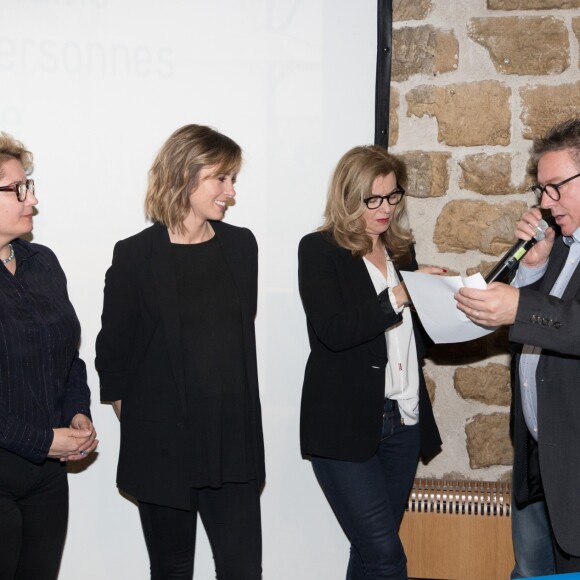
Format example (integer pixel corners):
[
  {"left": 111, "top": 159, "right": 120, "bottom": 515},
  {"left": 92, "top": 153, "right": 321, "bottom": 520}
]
[{"left": 0, "top": 0, "right": 377, "bottom": 580}]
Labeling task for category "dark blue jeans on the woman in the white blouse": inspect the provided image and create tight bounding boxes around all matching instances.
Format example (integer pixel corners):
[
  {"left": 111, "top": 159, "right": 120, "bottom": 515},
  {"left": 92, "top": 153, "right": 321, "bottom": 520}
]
[{"left": 311, "top": 399, "right": 420, "bottom": 580}]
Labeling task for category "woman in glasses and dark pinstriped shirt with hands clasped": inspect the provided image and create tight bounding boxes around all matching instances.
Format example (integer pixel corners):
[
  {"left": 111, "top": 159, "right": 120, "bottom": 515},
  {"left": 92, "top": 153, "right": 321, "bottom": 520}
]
[{"left": 0, "top": 133, "right": 97, "bottom": 580}]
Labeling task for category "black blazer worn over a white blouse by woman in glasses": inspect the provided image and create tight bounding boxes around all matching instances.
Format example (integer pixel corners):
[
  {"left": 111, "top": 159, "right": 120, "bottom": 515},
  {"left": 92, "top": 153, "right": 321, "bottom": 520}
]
[{"left": 298, "top": 232, "right": 441, "bottom": 461}]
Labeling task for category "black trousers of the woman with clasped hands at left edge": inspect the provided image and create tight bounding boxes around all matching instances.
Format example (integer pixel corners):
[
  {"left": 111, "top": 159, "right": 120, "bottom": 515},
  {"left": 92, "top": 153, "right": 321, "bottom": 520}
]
[{"left": 0, "top": 449, "right": 68, "bottom": 580}]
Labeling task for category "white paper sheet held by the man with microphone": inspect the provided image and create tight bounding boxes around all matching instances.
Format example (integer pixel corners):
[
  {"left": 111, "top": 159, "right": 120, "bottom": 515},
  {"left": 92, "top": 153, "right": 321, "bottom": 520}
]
[{"left": 401, "top": 272, "right": 495, "bottom": 344}]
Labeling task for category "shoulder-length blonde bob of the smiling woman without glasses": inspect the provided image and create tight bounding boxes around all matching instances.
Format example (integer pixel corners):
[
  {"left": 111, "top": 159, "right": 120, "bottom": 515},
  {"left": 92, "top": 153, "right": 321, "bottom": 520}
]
[{"left": 145, "top": 125, "right": 242, "bottom": 234}]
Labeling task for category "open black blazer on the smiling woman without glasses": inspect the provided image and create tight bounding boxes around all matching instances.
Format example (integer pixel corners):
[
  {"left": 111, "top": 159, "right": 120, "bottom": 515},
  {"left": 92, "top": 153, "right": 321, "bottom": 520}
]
[{"left": 95, "top": 222, "right": 265, "bottom": 509}]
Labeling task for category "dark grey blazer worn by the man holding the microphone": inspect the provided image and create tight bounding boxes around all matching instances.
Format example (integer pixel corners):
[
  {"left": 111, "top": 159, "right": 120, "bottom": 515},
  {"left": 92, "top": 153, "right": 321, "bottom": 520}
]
[{"left": 510, "top": 237, "right": 580, "bottom": 557}]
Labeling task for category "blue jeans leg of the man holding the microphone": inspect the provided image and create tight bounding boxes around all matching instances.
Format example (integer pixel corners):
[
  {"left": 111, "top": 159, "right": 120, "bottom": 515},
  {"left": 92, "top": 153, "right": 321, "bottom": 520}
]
[{"left": 511, "top": 499, "right": 556, "bottom": 578}]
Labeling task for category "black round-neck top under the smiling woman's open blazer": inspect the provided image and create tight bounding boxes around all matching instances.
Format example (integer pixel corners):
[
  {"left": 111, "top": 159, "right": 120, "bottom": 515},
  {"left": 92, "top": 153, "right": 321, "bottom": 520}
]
[{"left": 172, "top": 237, "right": 257, "bottom": 487}]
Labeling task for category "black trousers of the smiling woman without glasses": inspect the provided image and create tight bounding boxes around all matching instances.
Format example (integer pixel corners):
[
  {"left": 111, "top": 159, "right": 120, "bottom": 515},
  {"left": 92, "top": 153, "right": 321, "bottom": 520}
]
[{"left": 139, "top": 481, "right": 262, "bottom": 580}]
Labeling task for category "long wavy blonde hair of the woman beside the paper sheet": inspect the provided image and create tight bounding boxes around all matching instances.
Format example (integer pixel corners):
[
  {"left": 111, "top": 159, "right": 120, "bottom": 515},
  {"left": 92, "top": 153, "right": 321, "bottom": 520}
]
[{"left": 320, "top": 145, "right": 413, "bottom": 264}]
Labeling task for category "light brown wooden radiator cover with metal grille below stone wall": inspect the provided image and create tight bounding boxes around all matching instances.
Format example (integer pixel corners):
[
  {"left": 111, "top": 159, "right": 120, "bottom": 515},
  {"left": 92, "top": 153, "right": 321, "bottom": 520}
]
[{"left": 400, "top": 479, "right": 514, "bottom": 580}]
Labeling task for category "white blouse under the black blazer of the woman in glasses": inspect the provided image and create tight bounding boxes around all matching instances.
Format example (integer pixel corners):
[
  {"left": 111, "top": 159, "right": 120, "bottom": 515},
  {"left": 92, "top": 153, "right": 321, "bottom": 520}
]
[{"left": 364, "top": 252, "right": 419, "bottom": 425}]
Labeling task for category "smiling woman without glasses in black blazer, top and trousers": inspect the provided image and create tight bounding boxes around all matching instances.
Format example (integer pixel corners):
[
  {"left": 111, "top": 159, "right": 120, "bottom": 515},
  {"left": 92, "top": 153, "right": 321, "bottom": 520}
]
[{"left": 96, "top": 125, "right": 265, "bottom": 580}]
